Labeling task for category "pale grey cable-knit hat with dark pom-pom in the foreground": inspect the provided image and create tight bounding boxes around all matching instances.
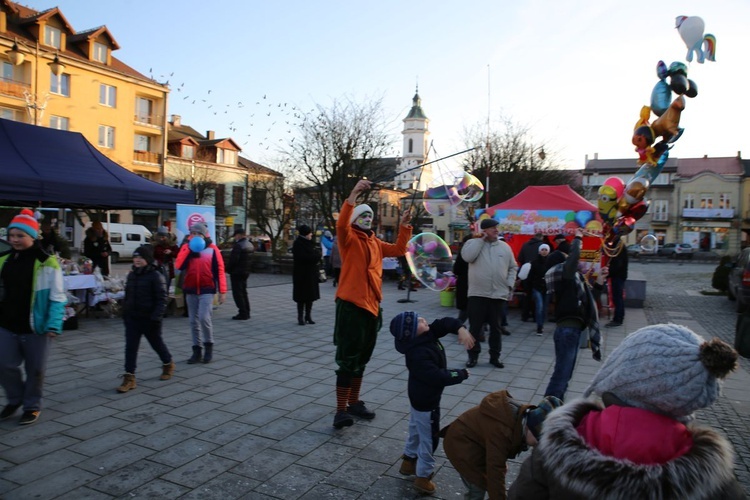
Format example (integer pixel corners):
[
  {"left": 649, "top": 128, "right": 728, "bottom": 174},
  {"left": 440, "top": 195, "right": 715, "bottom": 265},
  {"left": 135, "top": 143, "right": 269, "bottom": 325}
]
[{"left": 583, "top": 323, "right": 737, "bottom": 422}]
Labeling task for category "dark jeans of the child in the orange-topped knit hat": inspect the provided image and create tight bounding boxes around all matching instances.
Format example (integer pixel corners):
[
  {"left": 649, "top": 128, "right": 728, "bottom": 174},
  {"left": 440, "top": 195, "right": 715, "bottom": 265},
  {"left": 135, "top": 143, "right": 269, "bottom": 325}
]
[{"left": 0, "top": 328, "right": 51, "bottom": 411}]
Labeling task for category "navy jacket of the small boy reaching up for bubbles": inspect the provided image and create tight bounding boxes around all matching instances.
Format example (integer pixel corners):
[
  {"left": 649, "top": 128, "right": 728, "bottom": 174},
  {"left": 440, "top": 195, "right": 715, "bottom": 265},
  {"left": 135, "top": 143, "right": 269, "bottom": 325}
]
[{"left": 394, "top": 318, "right": 469, "bottom": 411}]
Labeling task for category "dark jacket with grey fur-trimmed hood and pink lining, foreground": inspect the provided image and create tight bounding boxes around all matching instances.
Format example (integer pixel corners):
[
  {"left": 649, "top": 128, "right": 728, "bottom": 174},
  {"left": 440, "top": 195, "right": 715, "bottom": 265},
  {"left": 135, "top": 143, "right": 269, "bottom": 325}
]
[{"left": 508, "top": 399, "right": 746, "bottom": 500}]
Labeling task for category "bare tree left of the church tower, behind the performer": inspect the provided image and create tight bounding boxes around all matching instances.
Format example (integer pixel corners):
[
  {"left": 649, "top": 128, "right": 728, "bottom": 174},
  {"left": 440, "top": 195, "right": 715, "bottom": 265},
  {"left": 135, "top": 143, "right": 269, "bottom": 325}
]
[{"left": 283, "top": 98, "right": 394, "bottom": 227}]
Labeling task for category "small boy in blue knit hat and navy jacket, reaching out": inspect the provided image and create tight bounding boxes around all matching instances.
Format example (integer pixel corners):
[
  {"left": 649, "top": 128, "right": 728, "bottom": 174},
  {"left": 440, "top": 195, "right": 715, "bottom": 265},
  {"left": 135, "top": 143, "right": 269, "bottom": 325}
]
[{"left": 391, "top": 311, "right": 474, "bottom": 494}]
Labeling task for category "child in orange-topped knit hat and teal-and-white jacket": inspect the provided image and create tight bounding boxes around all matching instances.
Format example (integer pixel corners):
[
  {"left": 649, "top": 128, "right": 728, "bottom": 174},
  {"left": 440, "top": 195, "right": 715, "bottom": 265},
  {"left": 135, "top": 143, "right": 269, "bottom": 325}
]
[{"left": 0, "top": 209, "right": 67, "bottom": 425}]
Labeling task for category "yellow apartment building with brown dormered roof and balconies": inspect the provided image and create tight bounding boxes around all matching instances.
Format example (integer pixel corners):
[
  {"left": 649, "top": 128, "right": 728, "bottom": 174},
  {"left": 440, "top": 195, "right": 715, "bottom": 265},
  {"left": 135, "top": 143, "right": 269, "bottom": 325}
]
[{"left": 0, "top": 0, "right": 169, "bottom": 227}]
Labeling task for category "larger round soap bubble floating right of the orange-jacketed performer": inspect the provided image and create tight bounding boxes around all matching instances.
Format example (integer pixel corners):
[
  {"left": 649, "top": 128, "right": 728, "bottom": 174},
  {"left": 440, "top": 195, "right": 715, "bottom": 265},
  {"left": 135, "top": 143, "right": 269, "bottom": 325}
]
[{"left": 406, "top": 233, "right": 453, "bottom": 292}]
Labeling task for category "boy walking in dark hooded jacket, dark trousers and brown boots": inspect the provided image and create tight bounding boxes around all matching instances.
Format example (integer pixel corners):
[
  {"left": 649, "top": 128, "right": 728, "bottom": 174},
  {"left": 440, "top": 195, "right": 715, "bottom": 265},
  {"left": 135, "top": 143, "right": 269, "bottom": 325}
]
[{"left": 117, "top": 245, "right": 175, "bottom": 393}]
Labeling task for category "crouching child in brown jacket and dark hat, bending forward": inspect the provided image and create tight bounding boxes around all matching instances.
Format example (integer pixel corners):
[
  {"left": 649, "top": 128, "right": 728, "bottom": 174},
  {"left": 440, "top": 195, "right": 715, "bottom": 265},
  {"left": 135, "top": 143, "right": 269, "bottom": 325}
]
[{"left": 440, "top": 390, "right": 562, "bottom": 500}]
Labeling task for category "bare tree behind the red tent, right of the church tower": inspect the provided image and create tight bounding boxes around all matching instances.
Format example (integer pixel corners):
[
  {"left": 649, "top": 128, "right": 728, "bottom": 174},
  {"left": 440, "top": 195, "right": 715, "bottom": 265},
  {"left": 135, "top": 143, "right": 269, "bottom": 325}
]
[{"left": 463, "top": 118, "right": 575, "bottom": 204}]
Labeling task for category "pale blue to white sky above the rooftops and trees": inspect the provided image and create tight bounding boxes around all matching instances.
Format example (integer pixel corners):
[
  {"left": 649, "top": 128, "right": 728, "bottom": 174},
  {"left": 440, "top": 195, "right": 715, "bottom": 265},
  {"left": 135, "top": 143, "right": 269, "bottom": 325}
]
[{"left": 21, "top": 0, "right": 750, "bottom": 176}]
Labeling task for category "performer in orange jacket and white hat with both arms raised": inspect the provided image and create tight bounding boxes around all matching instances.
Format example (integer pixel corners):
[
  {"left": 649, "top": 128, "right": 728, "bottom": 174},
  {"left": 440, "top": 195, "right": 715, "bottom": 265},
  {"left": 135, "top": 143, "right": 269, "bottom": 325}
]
[{"left": 333, "top": 179, "right": 412, "bottom": 429}]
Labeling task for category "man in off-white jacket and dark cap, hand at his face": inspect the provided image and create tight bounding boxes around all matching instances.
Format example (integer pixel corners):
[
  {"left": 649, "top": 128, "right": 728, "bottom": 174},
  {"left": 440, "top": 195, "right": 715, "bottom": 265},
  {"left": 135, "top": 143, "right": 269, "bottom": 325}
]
[{"left": 461, "top": 219, "right": 518, "bottom": 368}]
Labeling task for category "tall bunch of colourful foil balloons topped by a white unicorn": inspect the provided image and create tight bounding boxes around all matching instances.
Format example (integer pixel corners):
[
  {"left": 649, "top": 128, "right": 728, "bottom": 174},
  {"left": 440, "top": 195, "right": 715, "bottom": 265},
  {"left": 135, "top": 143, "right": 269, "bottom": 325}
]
[{"left": 597, "top": 16, "right": 716, "bottom": 248}]
